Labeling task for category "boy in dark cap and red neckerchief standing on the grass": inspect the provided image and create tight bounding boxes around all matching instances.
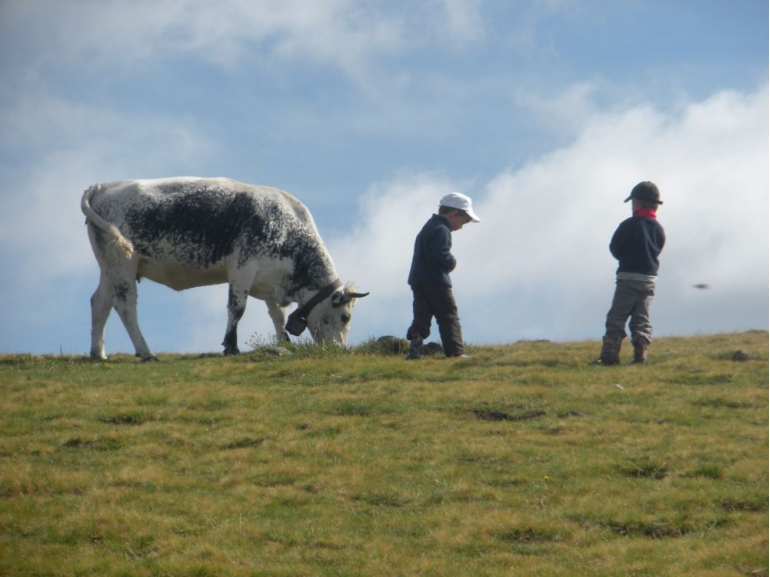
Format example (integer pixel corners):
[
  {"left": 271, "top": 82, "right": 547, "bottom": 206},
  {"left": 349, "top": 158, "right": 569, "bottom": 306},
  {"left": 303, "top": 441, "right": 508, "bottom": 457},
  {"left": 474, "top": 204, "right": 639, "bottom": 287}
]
[{"left": 597, "top": 181, "right": 666, "bottom": 365}]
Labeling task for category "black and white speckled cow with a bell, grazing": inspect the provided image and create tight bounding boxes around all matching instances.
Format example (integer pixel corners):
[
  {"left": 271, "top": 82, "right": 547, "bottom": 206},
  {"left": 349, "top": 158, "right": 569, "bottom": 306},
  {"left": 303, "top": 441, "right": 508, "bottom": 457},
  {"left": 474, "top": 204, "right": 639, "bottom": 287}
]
[{"left": 81, "top": 177, "right": 369, "bottom": 361}]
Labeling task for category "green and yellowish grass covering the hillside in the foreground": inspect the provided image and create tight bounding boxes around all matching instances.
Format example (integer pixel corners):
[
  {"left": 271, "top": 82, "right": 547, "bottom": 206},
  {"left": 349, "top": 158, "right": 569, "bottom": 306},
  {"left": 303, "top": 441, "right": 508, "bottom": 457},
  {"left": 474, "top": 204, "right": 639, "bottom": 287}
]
[{"left": 0, "top": 332, "right": 768, "bottom": 577}]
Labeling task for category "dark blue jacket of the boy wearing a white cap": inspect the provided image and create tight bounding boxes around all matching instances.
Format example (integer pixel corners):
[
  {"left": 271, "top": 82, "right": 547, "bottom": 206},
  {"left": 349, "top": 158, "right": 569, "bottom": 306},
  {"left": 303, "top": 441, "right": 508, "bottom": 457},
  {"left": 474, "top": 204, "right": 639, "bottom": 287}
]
[{"left": 409, "top": 214, "right": 457, "bottom": 287}]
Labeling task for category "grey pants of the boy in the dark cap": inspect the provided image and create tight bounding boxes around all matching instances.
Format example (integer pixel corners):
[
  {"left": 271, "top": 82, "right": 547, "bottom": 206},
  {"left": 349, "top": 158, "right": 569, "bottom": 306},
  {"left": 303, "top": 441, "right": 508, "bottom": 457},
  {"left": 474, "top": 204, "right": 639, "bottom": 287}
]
[{"left": 604, "top": 279, "right": 655, "bottom": 343}]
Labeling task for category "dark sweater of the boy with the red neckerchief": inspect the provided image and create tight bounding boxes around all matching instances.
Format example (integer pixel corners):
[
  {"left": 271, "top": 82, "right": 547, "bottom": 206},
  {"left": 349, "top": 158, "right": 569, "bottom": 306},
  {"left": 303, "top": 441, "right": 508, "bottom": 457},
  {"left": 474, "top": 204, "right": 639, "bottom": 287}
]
[{"left": 610, "top": 216, "right": 666, "bottom": 276}]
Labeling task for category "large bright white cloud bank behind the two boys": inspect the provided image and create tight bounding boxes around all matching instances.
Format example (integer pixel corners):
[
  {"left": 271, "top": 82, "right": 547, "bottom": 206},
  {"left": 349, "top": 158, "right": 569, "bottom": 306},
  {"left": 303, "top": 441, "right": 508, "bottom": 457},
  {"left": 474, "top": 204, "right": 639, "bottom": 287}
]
[{"left": 330, "top": 85, "right": 770, "bottom": 342}]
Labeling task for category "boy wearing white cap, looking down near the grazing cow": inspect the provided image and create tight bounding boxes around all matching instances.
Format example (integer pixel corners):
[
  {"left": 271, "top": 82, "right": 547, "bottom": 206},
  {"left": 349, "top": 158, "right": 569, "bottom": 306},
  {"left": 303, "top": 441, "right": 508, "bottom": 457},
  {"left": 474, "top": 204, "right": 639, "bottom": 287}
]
[{"left": 406, "top": 192, "right": 481, "bottom": 359}]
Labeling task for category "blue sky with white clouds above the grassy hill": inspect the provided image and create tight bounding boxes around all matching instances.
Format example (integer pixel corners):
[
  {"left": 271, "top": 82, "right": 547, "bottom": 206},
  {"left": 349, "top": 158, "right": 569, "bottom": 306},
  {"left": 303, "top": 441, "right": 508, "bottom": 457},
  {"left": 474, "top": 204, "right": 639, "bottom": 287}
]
[{"left": 0, "top": 0, "right": 770, "bottom": 354}]
